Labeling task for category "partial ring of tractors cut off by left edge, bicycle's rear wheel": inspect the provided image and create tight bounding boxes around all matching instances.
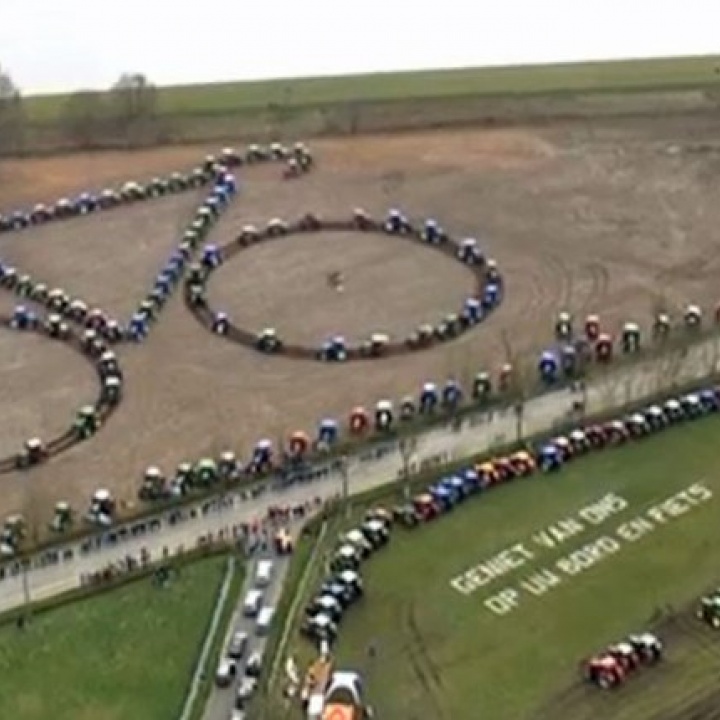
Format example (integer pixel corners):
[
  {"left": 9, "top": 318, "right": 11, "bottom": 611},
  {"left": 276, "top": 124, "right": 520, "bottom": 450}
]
[{"left": 0, "top": 305, "right": 123, "bottom": 473}]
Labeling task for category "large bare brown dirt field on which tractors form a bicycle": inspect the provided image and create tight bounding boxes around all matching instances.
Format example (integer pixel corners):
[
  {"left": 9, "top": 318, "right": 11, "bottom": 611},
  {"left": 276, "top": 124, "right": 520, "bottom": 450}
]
[{"left": 0, "top": 116, "right": 720, "bottom": 512}]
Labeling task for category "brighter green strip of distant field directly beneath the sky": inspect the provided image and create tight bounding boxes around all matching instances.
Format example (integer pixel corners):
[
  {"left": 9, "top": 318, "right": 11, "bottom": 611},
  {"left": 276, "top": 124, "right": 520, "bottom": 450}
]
[{"left": 26, "top": 56, "right": 720, "bottom": 123}]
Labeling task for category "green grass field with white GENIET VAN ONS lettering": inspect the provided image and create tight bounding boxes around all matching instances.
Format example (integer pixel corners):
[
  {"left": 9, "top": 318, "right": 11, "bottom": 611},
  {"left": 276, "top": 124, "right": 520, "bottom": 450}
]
[{"left": 286, "top": 418, "right": 720, "bottom": 720}]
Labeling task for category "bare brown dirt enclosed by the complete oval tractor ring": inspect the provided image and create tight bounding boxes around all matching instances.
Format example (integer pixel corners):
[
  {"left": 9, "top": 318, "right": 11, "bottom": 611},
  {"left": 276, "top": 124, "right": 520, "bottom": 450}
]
[{"left": 208, "top": 232, "right": 476, "bottom": 347}]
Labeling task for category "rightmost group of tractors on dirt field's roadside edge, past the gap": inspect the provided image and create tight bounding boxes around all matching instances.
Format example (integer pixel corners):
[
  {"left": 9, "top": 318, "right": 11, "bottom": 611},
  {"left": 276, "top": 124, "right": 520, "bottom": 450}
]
[{"left": 537, "top": 304, "right": 720, "bottom": 385}]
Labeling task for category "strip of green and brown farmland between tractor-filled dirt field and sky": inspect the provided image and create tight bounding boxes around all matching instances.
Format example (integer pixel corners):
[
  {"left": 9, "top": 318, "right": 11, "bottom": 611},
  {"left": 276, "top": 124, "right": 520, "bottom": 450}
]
[{"left": 8, "top": 56, "right": 720, "bottom": 155}]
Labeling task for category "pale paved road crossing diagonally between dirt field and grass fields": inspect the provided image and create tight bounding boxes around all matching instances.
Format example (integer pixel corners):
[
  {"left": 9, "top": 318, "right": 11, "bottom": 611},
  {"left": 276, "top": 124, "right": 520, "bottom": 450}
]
[{"left": 0, "top": 340, "right": 720, "bottom": 611}]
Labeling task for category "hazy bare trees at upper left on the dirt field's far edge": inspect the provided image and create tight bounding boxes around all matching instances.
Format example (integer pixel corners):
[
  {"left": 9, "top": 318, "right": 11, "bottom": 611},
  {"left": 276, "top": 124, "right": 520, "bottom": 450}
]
[{"left": 0, "top": 66, "right": 161, "bottom": 154}]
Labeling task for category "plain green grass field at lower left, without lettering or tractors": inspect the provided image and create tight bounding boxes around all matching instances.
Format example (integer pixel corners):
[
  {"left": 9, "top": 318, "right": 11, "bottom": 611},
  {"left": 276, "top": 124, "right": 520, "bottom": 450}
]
[{"left": 0, "top": 557, "right": 235, "bottom": 720}]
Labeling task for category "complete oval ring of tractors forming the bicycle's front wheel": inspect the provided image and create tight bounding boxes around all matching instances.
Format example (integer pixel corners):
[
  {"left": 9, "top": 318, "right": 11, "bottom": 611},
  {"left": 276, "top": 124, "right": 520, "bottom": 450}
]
[{"left": 185, "top": 210, "right": 504, "bottom": 362}]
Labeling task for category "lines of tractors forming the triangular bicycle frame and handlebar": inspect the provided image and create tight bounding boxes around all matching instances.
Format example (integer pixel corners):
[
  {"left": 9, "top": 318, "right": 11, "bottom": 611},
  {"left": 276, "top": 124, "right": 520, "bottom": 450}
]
[{"left": 0, "top": 143, "right": 313, "bottom": 343}]
